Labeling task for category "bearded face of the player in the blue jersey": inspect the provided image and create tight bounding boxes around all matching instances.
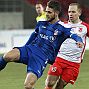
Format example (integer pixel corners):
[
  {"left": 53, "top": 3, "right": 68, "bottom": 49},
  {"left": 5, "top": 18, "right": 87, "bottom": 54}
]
[{"left": 45, "top": 6, "right": 55, "bottom": 22}]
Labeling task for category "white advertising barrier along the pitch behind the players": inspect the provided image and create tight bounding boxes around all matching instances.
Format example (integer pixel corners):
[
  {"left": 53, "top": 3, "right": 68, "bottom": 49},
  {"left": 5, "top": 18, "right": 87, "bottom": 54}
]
[{"left": 0, "top": 29, "right": 89, "bottom": 54}]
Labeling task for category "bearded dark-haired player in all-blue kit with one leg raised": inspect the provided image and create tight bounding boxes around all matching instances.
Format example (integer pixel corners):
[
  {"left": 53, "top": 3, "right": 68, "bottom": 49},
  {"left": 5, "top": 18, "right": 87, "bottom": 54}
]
[{"left": 0, "top": 0, "right": 82, "bottom": 89}]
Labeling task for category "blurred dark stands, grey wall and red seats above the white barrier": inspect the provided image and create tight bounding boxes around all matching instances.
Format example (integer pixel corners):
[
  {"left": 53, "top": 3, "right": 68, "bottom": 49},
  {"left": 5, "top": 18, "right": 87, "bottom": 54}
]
[{"left": 0, "top": 0, "right": 89, "bottom": 30}]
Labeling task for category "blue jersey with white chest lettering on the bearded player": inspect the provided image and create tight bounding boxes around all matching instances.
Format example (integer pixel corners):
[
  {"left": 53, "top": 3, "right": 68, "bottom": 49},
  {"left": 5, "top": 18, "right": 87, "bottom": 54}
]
[{"left": 27, "top": 21, "right": 82, "bottom": 61}]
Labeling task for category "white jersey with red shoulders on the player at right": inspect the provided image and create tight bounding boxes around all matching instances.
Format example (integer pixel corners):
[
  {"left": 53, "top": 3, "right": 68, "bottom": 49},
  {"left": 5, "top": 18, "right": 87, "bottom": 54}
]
[{"left": 57, "top": 21, "right": 89, "bottom": 63}]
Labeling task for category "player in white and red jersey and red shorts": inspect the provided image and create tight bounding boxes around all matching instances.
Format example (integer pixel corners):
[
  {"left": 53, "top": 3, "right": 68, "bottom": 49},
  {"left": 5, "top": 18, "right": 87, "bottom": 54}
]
[{"left": 45, "top": 3, "right": 89, "bottom": 89}]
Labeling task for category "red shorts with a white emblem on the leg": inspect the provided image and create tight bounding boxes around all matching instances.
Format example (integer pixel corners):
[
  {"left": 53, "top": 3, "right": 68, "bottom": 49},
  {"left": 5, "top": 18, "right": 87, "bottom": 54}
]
[{"left": 48, "top": 57, "right": 80, "bottom": 84}]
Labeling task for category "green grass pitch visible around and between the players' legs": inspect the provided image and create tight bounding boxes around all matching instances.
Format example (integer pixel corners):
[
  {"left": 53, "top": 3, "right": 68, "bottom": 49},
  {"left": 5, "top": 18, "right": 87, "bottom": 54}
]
[{"left": 0, "top": 51, "right": 89, "bottom": 89}]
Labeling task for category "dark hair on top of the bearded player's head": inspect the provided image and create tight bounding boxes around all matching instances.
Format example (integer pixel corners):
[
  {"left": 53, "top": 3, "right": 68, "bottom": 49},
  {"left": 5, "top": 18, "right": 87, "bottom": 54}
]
[{"left": 47, "top": 0, "right": 61, "bottom": 12}]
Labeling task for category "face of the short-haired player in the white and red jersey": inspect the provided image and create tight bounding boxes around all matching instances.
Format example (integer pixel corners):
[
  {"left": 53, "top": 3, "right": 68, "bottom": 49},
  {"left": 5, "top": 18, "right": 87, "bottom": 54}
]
[{"left": 68, "top": 5, "right": 81, "bottom": 22}]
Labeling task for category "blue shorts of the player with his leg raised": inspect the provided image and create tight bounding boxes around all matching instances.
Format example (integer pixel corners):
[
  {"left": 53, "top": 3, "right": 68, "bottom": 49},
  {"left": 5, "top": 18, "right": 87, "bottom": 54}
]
[{"left": 15, "top": 46, "right": 48, "bottom": 78}]
